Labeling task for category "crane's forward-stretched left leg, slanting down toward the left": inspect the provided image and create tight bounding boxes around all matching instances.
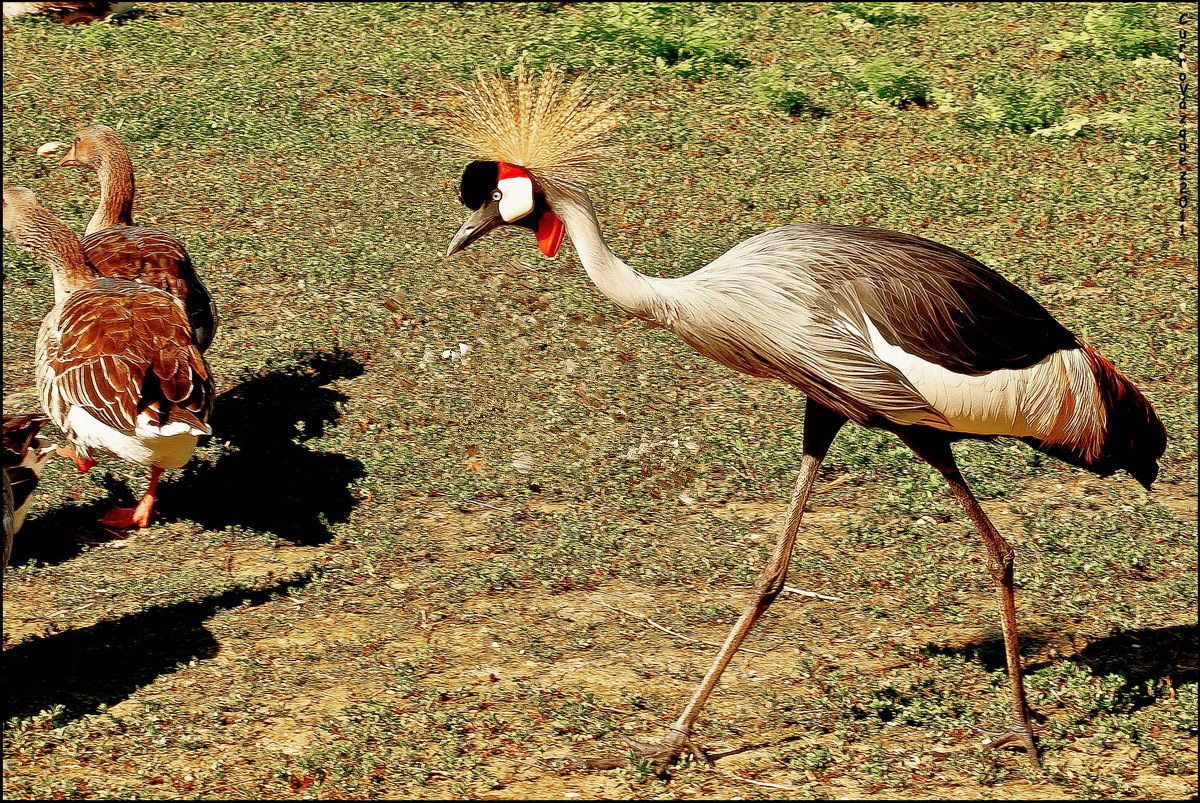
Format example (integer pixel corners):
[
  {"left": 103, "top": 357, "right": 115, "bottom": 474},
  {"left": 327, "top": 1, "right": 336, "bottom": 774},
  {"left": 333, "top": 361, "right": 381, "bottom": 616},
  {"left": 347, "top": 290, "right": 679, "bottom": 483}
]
[{"left": 649, "top": 401, "right": 846, "bottom": 774}]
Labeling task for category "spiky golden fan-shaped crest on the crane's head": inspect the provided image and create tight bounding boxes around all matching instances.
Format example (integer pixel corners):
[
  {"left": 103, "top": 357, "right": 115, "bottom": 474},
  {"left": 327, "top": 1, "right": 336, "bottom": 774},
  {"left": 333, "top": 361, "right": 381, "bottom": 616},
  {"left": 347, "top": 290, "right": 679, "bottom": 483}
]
[{"left": 438, "top": 59, "right": 618, "bottom": 184}]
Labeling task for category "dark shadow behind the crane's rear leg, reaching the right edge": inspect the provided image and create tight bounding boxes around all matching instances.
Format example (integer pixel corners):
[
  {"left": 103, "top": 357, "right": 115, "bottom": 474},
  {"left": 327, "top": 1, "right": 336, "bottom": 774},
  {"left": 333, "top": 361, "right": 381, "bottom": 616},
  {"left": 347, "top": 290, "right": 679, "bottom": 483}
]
[{"left": 922, "top": 624, "right": 1200, "bottom": 707}]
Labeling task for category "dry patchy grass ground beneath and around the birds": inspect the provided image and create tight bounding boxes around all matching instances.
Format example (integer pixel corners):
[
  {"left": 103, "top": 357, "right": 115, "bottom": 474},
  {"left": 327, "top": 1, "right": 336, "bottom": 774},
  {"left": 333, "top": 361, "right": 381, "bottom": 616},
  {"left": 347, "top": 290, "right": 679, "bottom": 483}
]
[{"left": 2, "top": 4, "right": 1196, "bottom": 799}]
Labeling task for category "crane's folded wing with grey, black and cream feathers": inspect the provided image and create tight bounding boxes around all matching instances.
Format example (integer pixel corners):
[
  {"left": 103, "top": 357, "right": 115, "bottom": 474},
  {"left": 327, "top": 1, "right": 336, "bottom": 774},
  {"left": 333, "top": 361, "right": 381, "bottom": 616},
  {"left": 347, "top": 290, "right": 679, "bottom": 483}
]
[{"left": 686, "top": 226, "right": 1104, "bottom": 444}]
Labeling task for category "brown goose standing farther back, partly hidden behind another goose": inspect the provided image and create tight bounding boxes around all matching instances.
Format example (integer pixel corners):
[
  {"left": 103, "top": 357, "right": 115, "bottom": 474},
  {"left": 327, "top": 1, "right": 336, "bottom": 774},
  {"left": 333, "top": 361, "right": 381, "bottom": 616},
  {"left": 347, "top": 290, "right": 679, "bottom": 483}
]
[{"left": 37, "top": 126, "right": 217, "bottom": 352}]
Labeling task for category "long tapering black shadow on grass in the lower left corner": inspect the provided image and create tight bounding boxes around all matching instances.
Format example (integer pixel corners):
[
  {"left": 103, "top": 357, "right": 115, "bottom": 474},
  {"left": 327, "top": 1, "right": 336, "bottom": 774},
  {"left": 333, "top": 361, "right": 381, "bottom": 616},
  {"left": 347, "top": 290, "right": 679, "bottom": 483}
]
[{"left": 0, "top": 570, "right": 313, "bottom": 727}]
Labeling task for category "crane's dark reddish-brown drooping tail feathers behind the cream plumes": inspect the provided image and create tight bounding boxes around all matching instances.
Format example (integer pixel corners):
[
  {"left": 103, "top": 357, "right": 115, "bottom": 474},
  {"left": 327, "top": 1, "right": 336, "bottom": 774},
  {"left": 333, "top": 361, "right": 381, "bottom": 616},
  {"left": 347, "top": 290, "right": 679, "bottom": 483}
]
[{"left": 1024, "top": 346, "right": 1166, "bottom": 490}]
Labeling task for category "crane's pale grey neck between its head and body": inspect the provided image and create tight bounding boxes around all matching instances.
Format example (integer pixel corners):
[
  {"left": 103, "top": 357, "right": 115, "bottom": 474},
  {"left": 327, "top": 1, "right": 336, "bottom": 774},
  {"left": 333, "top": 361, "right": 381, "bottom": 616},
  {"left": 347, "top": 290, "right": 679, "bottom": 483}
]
[{"left": 546, "top": 187, "right": 665, "bottom": 320}]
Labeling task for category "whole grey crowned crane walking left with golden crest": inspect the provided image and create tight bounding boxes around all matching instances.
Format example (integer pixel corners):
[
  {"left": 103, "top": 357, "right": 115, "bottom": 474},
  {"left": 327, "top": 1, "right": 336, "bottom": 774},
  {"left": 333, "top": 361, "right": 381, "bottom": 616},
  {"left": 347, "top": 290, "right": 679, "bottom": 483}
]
[{"left": 442, "top": 65, "right": 1166, "bottom": 773}]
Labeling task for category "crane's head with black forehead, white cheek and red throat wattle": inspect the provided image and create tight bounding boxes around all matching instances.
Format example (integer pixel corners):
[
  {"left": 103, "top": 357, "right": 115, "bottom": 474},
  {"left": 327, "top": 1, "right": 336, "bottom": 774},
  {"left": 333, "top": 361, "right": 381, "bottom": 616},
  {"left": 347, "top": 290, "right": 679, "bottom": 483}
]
[{"left": 446, "top": 162, "right": 564, "bottom": 258}]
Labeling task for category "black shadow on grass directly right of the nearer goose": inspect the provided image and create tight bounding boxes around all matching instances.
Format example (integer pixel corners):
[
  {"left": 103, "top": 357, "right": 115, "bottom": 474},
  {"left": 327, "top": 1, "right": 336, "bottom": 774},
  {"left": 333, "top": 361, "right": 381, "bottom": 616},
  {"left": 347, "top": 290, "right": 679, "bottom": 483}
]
[{"left": 158, "top": 349, "right": 366, "bottom": 545}]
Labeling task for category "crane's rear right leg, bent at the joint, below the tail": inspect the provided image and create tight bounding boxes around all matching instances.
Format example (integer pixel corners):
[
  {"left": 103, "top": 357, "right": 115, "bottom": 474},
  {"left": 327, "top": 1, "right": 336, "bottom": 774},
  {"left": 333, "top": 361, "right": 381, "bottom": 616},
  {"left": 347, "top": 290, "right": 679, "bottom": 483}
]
[{"left": 900, "top": 432, "right": 1042, "bottom": 769}]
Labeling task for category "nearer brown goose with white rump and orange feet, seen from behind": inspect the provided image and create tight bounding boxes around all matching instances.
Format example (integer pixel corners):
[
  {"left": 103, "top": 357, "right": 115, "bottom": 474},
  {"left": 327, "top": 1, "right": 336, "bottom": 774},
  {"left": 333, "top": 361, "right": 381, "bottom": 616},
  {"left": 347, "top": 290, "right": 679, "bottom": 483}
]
[{"left": 4, "top": 187, "right": 214, "bottom": 528}]
